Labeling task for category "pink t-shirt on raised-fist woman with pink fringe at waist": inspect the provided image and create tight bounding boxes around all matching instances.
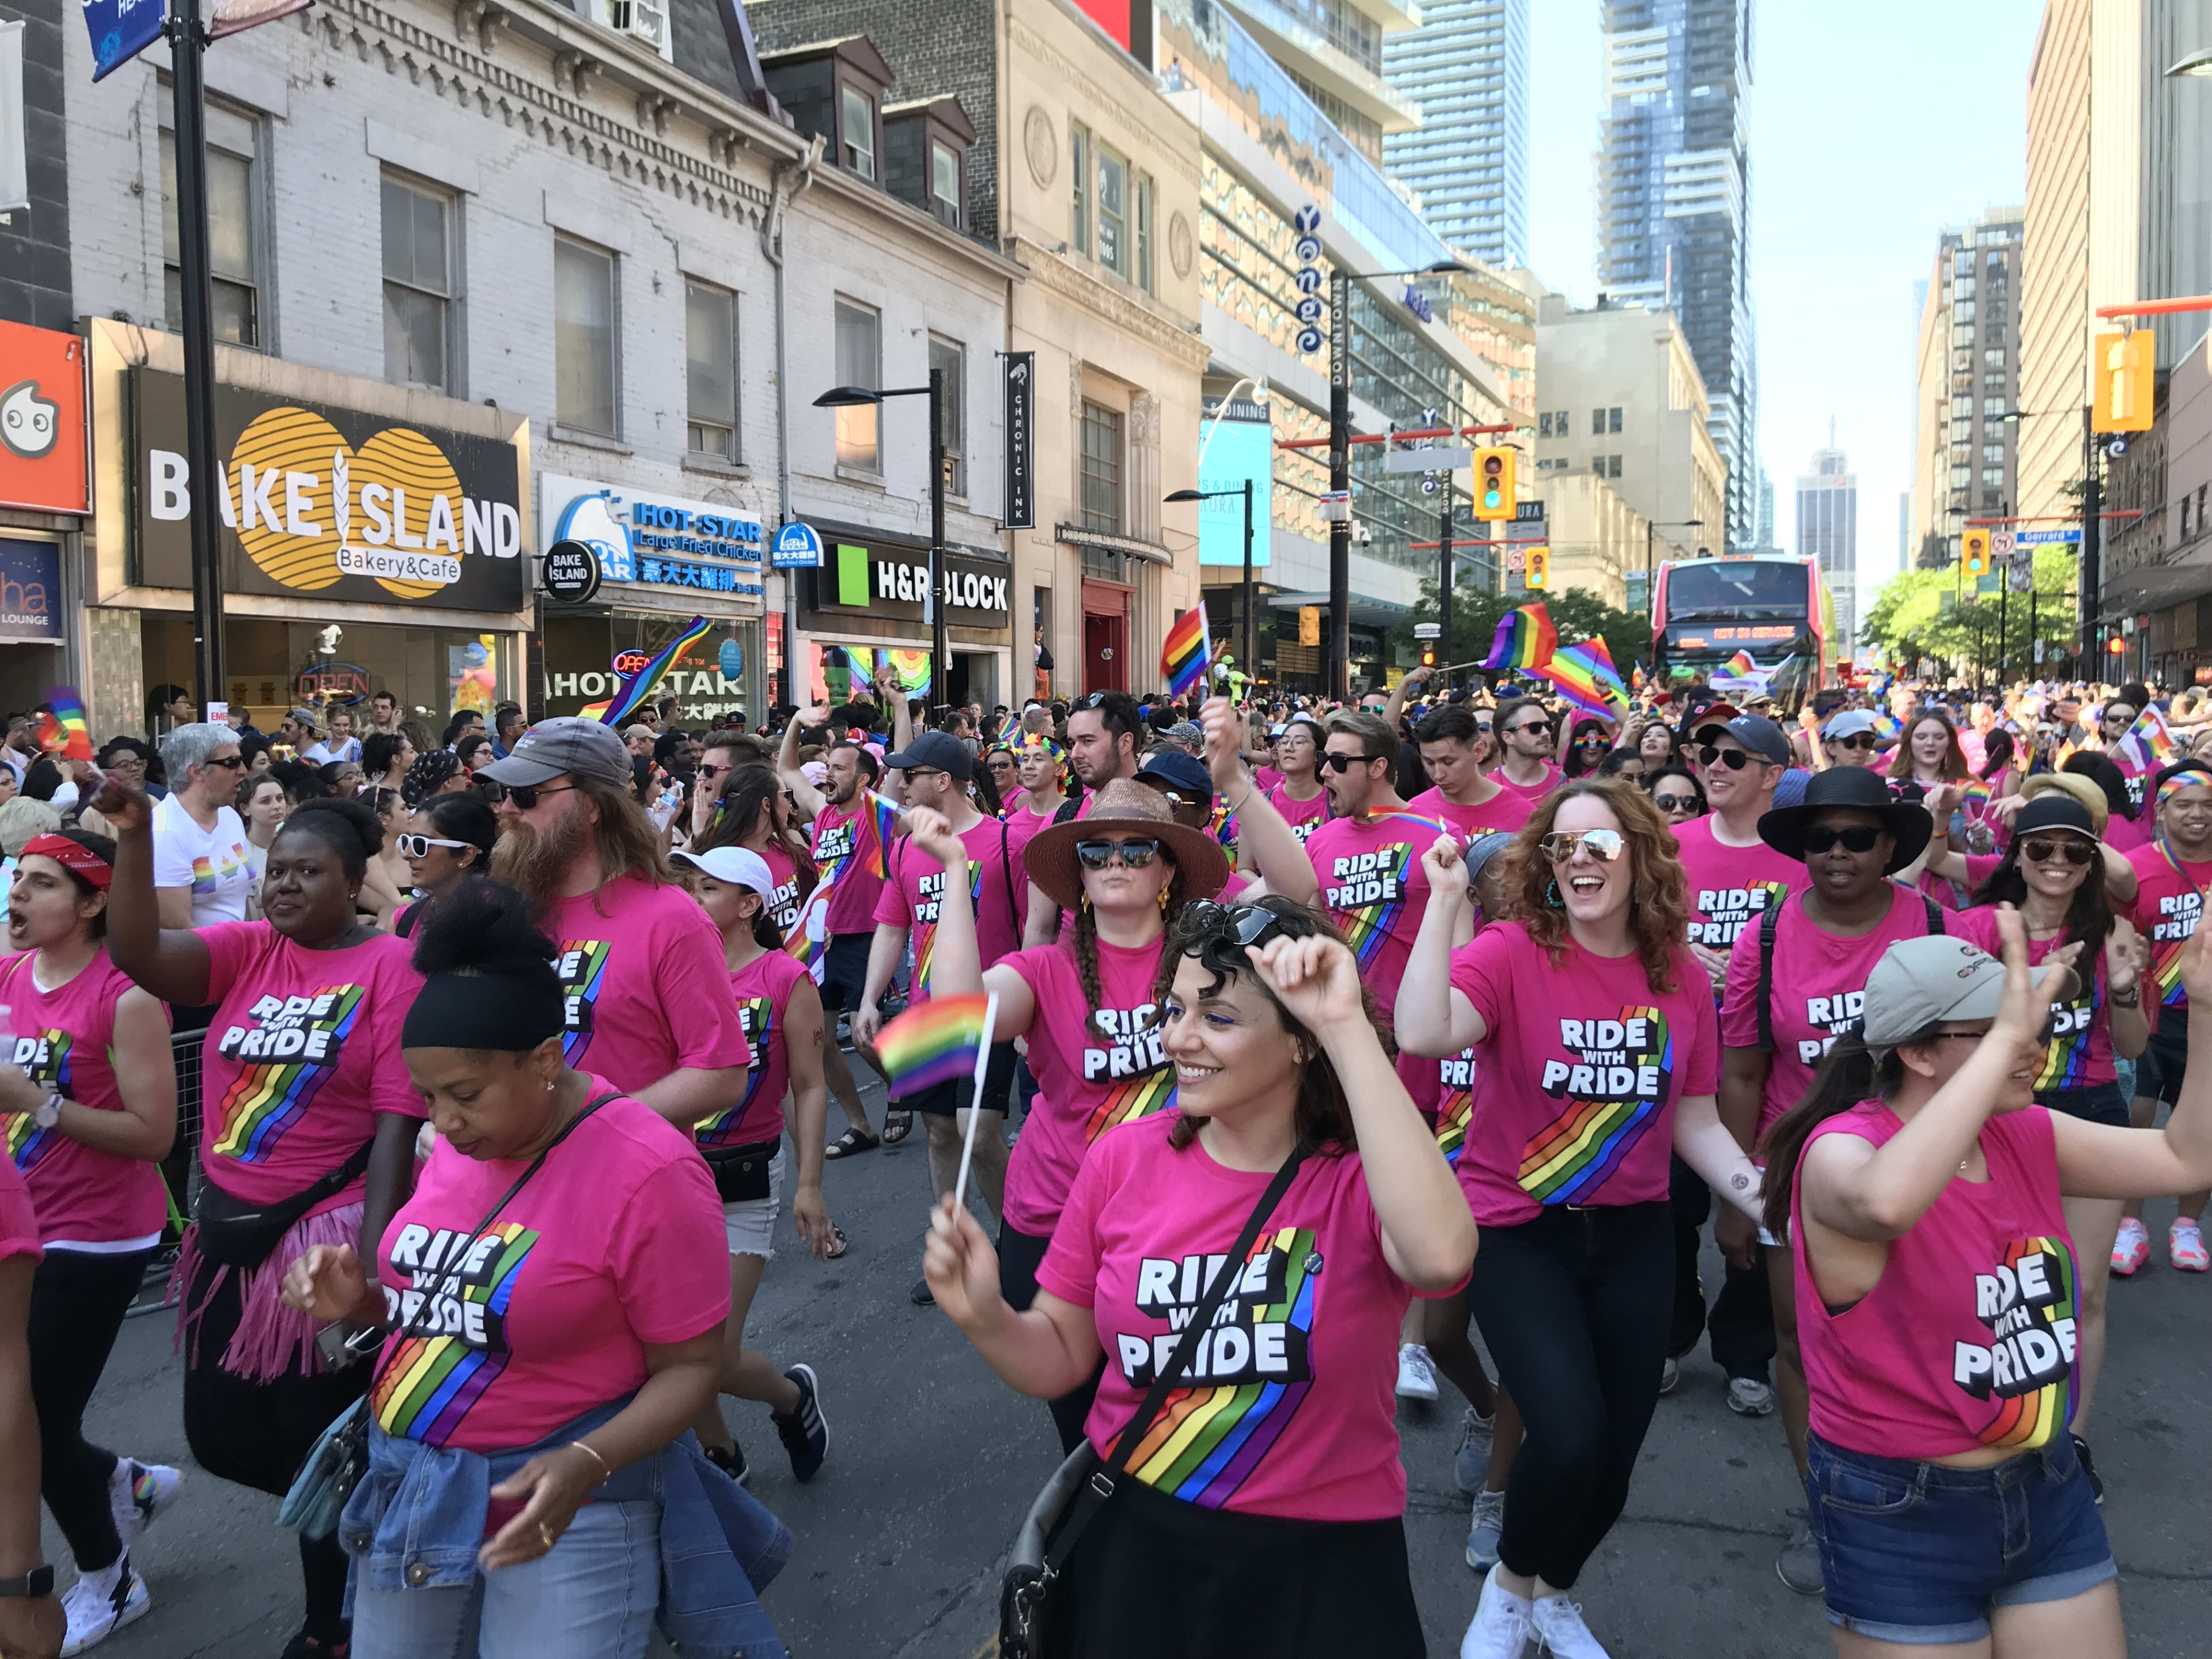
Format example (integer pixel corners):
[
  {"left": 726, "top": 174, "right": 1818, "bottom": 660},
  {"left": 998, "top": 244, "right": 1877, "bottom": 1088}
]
[{"left": 199, "top": 922, "right": 427, "bottom": 1214}]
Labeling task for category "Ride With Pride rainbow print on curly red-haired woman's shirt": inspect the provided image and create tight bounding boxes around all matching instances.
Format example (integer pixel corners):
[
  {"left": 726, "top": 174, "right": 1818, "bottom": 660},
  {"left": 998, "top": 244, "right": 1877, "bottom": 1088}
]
[{"left": 1520, "top": 1006, "right": 1675, "bottom": 1203}]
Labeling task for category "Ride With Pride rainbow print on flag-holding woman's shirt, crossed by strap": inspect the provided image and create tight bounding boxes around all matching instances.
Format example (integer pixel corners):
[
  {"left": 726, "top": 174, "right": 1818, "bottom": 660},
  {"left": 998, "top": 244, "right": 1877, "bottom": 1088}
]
[{"left": 1108, "top": 1228, "right": 1323, "bottom": 1509}]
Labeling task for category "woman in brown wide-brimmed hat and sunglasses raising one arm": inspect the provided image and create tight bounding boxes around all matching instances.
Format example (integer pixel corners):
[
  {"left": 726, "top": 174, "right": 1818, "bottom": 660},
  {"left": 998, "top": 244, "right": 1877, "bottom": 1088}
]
[{"left": 911, "top": 779, "right": 1228, "bottom": 1451}]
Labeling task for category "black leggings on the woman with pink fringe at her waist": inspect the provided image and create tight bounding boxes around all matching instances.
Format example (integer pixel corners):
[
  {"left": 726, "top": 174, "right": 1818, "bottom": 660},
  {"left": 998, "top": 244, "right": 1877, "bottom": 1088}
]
[{"left": 184, "top": 1261, "right": 376, "bottom": 1643}]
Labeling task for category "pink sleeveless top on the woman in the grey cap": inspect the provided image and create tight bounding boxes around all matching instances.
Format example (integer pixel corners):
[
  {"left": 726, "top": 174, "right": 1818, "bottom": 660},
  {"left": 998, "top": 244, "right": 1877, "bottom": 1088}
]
[{"left": 1790, "top": 1099, "right": 2077, "bottom": 1460}]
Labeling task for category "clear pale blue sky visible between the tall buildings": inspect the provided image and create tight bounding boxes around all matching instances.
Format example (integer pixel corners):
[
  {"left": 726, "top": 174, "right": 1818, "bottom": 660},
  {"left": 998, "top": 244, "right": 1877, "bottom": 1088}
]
[{"left": 1528, "top": 0, "right": 2044, "bottom": 588}]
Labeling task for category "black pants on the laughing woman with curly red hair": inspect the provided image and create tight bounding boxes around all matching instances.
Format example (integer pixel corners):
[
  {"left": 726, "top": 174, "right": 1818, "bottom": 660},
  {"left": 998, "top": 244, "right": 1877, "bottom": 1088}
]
[{"left": 1467, "top": 1201, "right": 1675, "bottom": 1590}]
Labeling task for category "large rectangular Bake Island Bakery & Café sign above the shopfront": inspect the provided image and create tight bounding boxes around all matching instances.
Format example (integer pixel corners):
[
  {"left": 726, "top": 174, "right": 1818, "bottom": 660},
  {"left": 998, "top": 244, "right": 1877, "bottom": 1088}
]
[{"left": 131, "top": 367, "right": 527, "bottom": 611}]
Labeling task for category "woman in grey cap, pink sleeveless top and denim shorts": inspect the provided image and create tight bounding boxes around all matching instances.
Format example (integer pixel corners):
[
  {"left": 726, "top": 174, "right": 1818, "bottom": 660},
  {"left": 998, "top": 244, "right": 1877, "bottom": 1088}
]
[{"left": 1765, "top": 929, "right": 2212, "bottom": 1659}]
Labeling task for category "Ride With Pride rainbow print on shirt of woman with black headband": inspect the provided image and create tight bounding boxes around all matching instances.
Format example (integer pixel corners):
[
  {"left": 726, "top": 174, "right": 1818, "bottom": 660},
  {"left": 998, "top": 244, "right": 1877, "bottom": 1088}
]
[{"left": 369, "top": 1221, "right": 537, "bottom": 1446}]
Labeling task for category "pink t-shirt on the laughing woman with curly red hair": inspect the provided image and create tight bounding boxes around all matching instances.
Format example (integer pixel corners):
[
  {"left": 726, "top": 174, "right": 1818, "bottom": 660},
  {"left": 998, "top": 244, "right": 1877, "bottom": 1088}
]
[{"left": 1451, "top": 922, "right": 1721, "bottom": 1228}]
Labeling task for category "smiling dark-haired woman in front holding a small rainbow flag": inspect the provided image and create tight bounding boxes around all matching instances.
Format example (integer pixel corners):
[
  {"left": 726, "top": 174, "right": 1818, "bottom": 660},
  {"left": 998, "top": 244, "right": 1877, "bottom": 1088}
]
[{"left": 922, "top": 898, "right": 1475, "bottom": 1659}]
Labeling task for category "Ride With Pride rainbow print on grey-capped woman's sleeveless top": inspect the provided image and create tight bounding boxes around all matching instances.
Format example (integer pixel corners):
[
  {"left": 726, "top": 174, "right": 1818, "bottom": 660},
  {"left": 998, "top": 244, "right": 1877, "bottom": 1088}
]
[{"left": 1951, "top": 1234, "right": 2077, "bottom": 1451}]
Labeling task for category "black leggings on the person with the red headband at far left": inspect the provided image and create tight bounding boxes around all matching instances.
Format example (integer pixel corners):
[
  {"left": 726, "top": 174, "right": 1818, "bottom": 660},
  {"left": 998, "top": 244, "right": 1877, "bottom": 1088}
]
[{"left": 31, "top": 1250, "right": 153, "bottom": 1573}]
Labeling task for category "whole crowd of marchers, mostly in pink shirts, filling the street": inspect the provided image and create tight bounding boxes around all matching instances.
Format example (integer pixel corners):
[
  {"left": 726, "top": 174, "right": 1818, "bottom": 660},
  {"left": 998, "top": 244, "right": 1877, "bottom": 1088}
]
[{"left": 0, "top": 671, "right": 2212, "bottom": 1659}]
